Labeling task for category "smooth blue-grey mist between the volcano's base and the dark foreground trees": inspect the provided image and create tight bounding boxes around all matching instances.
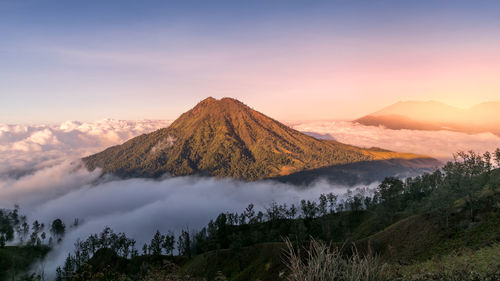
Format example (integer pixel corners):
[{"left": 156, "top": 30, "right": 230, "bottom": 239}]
[{"left": 0, "top": 162, "right": 377, "bottom": 276}]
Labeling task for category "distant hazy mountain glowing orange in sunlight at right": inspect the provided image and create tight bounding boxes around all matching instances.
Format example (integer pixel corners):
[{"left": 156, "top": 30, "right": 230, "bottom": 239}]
[{"left": 355, "top": 101, "right": 500, "bottom": 136}]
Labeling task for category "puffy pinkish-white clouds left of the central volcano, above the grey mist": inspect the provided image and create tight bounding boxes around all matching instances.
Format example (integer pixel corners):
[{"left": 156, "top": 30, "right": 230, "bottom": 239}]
[{"left": 0, "top": 119, "right": 171, "bottom": 177}]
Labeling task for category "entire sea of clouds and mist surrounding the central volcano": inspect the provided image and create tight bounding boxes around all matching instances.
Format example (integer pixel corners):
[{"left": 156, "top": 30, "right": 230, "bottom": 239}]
[{"left": 0, "top": 119, "right": 500, "bottom": 273}]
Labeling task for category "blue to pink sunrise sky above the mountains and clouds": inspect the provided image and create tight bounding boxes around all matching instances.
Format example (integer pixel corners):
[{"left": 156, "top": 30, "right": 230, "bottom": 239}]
[{"left": 0, "top": 0, "right": 500, "bottom": 124}]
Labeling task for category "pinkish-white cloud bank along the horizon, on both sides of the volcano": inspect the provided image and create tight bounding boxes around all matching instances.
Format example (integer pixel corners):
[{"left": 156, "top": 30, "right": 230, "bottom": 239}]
[{"left": 0, "top": 119, "right": 500, "bottom": 178}]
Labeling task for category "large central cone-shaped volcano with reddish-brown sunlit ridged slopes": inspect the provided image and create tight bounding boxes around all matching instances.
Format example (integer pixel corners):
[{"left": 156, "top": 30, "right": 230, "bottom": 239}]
[{"left": 83, "top": 97, "right": 432, "bottom": 180}]
